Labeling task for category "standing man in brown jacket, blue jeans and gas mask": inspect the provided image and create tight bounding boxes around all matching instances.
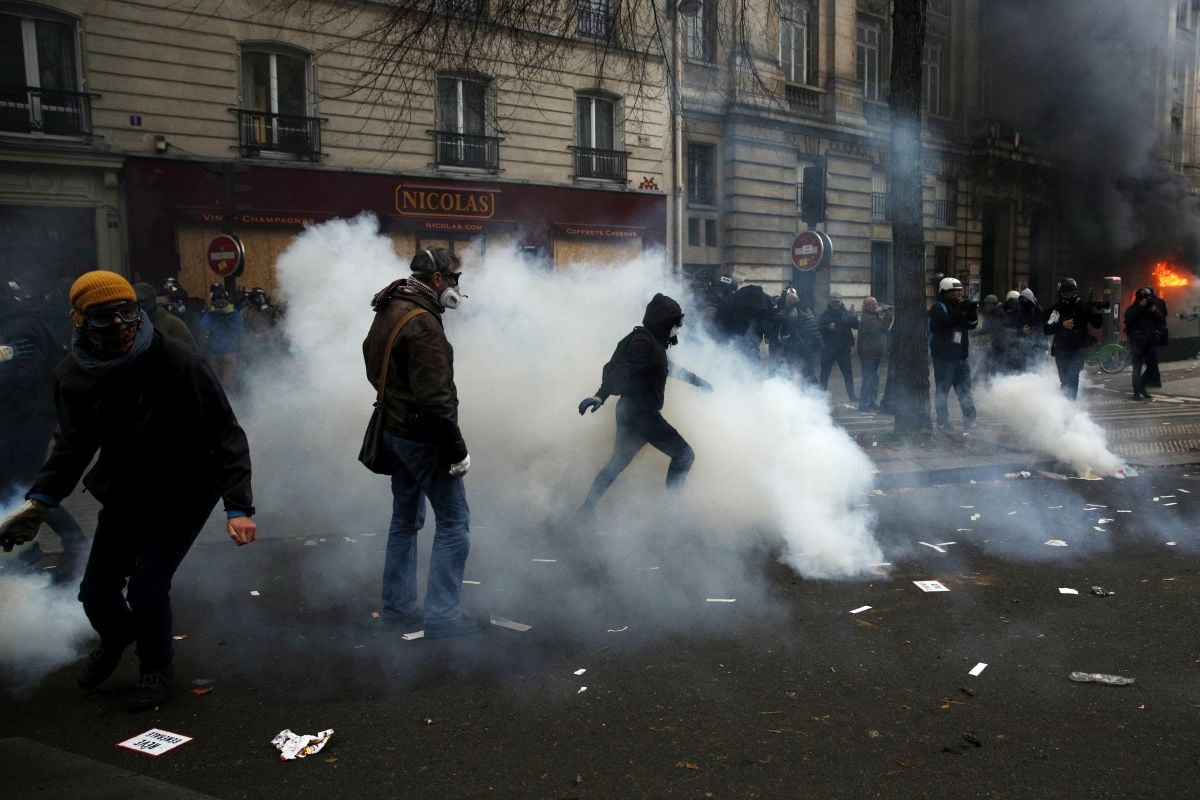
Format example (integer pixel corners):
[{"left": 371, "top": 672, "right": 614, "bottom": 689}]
[{"left": 362, "top": 247, "right": 488, "bottom": 639}]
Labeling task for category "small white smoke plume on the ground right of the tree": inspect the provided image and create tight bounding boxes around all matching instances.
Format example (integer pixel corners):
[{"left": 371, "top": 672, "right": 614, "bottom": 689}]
[{"left": 979, "top": 362, "right": 1123, "bottom": 475}]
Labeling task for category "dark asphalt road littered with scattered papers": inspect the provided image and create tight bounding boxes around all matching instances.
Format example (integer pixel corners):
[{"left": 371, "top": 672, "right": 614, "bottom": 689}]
[{"left": 0, "top": 467, "right": 1200, "bottom": 800}]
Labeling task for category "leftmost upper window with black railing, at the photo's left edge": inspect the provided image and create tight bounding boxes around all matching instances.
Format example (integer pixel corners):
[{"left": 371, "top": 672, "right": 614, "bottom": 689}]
[{"left": 0, "top": 8, "right": 91, "bottom": 137}]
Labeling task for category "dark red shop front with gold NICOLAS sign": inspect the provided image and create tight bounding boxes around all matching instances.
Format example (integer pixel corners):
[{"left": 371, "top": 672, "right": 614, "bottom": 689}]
[{"left": 124, "top": 158, "right": 666, "bottom": 296}]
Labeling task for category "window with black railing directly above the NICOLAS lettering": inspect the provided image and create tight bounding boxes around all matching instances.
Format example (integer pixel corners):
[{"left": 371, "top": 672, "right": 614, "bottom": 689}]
[{"left": 433, "top": 76, "right": 499, "bottom": 170}]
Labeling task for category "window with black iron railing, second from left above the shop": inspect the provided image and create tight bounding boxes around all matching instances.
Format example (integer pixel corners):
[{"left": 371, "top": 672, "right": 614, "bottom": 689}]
[{"left": 238, "top": 46, "right": 320, "bottom": 158}]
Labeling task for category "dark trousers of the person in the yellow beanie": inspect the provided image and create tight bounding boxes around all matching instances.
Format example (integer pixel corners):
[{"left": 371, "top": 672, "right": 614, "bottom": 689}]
[{"left": 79, "top": 492, "right": 220, "bottom": 673}]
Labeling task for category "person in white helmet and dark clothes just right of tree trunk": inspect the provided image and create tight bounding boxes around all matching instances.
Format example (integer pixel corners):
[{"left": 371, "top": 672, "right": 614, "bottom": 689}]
[{"left": 929, "top": 278, "right": 979, "bottom": 431}]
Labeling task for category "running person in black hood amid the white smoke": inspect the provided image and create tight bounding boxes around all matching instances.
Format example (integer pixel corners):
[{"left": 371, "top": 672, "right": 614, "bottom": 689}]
[{"left": 578, "top": 293, "right": 713, "bottom": 515}]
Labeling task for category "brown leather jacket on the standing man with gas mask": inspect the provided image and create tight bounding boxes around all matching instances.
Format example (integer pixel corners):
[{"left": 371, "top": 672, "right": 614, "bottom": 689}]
[{"left": 362, "top": 281, "right": 467, "bottom": 463}]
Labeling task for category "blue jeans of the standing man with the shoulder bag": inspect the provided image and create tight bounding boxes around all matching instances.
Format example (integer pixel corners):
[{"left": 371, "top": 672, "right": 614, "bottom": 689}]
[{"left": 382, "top": 432, "right": 470, "bottom": 625}]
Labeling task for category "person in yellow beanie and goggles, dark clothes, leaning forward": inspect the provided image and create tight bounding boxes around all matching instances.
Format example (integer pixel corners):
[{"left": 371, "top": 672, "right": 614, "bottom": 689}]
[{"left": 0, "top": 270, "right": 256, "bottom": 711}]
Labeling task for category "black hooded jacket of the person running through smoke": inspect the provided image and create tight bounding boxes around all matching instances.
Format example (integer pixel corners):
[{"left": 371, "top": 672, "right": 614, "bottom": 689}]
[{"left": 596, "top": 293, "right": 683, "bottom": 411}]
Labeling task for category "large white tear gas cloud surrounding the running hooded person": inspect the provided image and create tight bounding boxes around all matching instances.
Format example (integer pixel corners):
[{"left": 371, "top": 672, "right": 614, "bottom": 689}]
[{"left": 240, "top": 215, "right": 882, "bottom": 594}]
